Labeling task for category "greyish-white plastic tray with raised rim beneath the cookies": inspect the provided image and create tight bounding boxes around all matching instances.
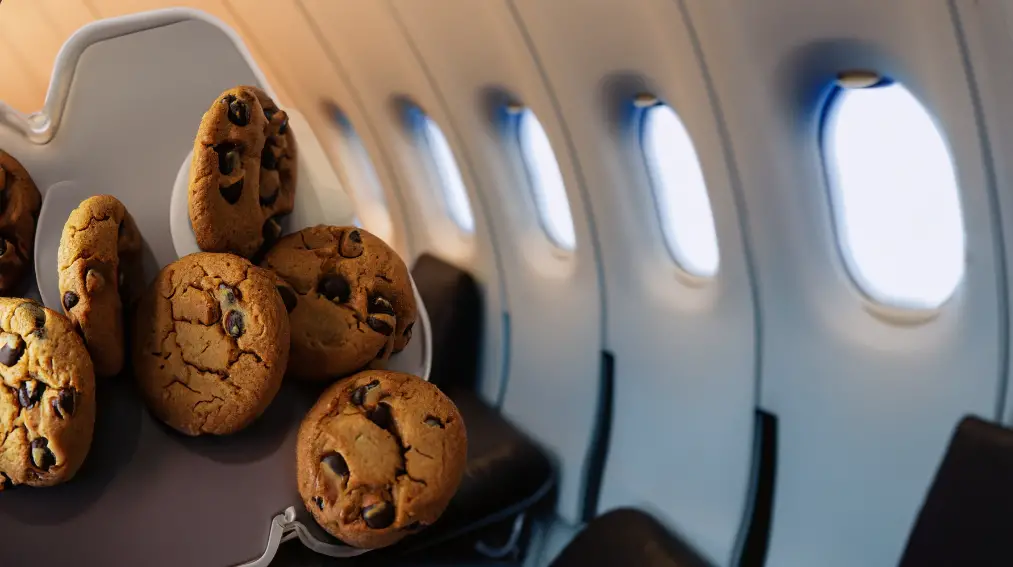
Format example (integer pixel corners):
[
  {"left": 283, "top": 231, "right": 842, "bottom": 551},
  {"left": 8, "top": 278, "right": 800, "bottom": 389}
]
[{"left": 0, "top": 9, "right": 432, "bottom": 567}]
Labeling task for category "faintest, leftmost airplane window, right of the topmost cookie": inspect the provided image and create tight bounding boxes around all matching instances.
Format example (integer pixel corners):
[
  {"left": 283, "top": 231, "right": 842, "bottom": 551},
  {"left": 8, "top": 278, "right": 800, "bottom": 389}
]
[{"left": 324, "top": 101, "right": 394, "bottom": 242}]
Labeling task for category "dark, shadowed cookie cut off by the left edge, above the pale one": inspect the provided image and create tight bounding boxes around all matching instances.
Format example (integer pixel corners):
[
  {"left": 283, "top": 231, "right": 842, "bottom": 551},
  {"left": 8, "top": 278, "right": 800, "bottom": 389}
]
[{"left": 0, "top": 150, "right": 43, "bottom": 294}]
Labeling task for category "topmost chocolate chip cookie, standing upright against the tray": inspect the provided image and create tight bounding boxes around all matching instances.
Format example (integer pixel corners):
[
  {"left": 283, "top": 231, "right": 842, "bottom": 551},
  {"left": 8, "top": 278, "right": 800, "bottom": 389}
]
[{"left": 188, "top": 86, "right": 297, "bottom": 258}]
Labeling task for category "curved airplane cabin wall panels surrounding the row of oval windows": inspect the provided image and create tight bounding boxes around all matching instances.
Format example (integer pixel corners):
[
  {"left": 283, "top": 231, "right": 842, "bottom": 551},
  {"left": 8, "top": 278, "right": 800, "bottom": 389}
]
[{"left": 0, "top": 0, "right": 1013, "bottom": 567}]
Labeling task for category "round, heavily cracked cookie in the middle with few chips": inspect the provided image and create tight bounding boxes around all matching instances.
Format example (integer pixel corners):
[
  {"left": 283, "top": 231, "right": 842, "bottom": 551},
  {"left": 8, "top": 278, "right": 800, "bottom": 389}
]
[{"left": 134, "top": 252, "right": 290, "bottom": 435}]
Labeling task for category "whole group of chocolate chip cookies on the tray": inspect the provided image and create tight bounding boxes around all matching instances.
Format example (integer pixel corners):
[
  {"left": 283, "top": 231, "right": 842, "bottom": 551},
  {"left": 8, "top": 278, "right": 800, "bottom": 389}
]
[{"left": 0, "top": 86, "right": 467, "bottom": 548}]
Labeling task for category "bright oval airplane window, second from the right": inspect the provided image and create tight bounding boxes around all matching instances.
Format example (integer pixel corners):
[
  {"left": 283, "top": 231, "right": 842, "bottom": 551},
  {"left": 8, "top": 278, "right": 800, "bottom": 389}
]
[{"left": 642, "top": 104, "right": 719, "bottom": 277}]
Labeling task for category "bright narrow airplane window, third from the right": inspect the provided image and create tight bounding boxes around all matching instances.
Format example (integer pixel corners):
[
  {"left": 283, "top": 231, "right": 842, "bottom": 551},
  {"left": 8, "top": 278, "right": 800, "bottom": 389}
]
[{"left": 518, "top": 109, "right": 576, "bottom": 250}]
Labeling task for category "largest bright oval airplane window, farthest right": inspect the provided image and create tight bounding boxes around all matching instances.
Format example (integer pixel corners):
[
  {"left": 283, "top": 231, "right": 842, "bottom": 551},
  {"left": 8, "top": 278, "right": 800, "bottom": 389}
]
[{"left": 823, "top": 79, "right": 964, "bottom": 309}]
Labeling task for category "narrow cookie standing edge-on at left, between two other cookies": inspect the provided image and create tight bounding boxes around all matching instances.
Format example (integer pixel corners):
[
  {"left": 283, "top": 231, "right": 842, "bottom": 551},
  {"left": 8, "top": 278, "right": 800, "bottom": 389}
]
[{"left": 59, "top": 195, "right": 143, "bottom": 377}]
